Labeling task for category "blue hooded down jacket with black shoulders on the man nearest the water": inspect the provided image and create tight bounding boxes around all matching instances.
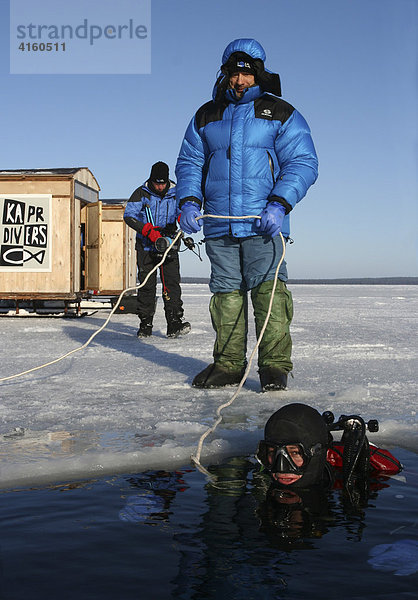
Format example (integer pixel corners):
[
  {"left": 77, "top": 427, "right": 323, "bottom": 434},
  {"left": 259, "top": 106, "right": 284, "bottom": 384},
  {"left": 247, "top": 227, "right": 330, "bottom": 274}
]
[{"left": 176, "top": 39, "right": 318, "bottom": 238}]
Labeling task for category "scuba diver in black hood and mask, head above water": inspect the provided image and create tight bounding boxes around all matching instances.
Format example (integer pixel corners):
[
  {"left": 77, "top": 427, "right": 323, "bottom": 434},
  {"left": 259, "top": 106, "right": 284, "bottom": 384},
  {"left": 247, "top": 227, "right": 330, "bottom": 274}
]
[{"left": 256, "top": 403, "right": 402, "bottom": 489}]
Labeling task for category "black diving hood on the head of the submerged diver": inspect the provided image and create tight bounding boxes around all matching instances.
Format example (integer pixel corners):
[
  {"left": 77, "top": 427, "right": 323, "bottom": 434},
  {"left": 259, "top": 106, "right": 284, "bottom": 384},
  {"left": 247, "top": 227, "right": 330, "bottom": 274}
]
[{"left": 264, "top": 403, "right": 328, "bottom": 488}]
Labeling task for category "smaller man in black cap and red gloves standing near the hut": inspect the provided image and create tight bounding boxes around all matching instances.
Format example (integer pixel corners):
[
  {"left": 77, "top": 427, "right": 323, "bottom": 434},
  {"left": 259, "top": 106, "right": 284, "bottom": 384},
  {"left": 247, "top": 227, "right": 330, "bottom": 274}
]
[{"left": 123, "top": 161, "right": 190, "bottom": 338}]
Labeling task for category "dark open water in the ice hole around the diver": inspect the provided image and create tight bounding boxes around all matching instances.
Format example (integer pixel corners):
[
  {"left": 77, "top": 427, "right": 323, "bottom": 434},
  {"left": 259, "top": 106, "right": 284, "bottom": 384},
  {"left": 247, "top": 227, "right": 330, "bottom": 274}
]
[{"left": 0, "top": 449, "right": 418, "bottom": 600}]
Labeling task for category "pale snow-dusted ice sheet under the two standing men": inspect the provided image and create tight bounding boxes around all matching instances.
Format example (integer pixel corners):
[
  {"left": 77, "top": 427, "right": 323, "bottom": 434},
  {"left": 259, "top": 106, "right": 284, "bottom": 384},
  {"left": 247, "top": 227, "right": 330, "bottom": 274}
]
[{"left": 0, "top": 284, "right": 418, "bottom": 487}]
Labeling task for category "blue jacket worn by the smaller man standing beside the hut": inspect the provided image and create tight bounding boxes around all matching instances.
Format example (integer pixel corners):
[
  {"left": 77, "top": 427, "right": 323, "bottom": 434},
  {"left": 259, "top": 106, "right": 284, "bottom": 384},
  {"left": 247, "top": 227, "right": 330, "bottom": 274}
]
[{"left": 123, "top": 181, "right": 180, "bottom": 250}]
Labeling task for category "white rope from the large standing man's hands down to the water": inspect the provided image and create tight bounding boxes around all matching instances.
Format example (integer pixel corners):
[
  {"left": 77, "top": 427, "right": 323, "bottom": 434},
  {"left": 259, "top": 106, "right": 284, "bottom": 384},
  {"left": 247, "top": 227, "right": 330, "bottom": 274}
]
[{"left": 191, "top": 215, "right": 286, "bottom": 482}]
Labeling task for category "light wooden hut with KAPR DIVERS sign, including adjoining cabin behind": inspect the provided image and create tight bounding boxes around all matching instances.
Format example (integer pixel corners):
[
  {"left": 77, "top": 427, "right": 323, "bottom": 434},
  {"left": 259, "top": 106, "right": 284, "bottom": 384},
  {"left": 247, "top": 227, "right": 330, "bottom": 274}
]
[{"left": 0, "top": 167, "right": 136, "bottom": 310}]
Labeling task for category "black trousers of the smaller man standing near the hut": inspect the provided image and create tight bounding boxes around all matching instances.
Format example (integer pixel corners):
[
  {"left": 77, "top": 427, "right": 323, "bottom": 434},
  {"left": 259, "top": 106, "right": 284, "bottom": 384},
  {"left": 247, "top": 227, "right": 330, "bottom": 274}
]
[{"left": 136, "top": 243, "right": 183, "bottom": 323}]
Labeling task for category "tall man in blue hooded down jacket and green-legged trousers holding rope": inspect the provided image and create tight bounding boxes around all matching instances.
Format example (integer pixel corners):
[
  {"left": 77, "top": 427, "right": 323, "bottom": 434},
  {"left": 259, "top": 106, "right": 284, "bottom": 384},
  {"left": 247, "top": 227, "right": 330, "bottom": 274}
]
[{"left": 176, "top": 39, "right": 318, "bottom": 391}]
